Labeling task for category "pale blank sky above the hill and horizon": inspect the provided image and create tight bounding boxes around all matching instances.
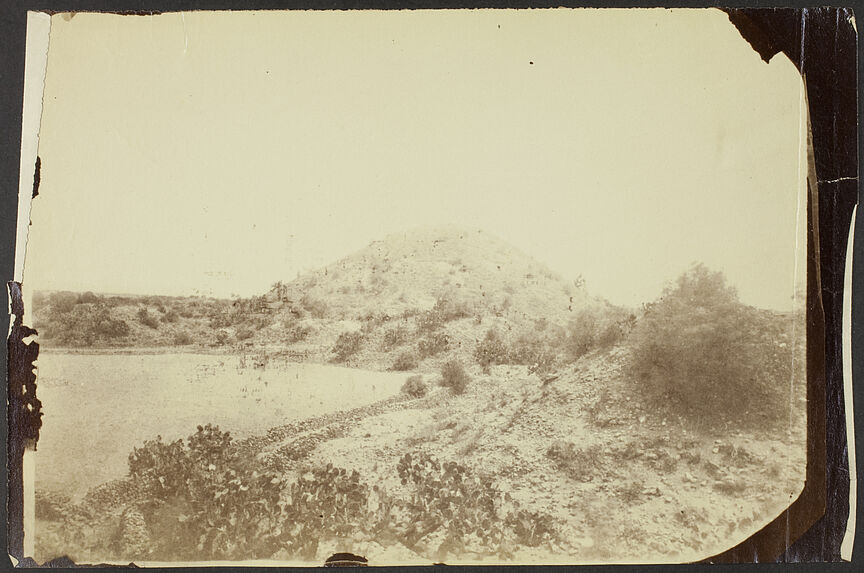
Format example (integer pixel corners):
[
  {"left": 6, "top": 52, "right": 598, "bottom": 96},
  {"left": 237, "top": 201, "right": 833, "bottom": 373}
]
[{"left": 24, "top": 9, "right": 806, "bottom": 308}]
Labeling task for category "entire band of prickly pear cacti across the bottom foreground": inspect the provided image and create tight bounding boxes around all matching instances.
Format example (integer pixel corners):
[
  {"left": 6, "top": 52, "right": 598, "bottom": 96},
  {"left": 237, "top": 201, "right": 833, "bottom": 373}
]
[{"left": 44, "top": 425, "right": 560, "bottom": 560}]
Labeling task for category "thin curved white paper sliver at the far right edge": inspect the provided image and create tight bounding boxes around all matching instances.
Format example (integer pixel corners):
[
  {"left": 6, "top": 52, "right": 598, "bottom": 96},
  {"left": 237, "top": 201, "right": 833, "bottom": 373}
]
[{"left": 840, "top": 205, "right": 858, "bottom": 561}]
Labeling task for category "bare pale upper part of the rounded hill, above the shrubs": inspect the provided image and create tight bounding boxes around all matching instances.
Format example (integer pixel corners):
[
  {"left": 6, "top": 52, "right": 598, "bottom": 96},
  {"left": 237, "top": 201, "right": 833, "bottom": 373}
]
[{"left": 269, "top": 227, "right": 597, "bottom": 328}]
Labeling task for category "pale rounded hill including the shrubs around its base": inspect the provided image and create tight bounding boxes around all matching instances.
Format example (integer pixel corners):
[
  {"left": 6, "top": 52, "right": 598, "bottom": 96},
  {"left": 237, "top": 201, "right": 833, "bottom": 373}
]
[{"left": 253, "top": 227, "right": 622, "bottom": 370}]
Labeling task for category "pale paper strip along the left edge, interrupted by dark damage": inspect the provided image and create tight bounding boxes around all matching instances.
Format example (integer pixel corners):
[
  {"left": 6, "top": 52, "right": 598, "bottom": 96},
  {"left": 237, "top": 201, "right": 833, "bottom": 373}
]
[{"left": 13, "top": 12, "right": 51, "bottom": 556}]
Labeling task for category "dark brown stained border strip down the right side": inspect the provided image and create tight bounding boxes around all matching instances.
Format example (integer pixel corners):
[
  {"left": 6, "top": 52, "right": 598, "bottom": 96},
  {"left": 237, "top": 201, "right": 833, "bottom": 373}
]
[{"left": 712, "top": 8, "right": 858, "bottom": 563}]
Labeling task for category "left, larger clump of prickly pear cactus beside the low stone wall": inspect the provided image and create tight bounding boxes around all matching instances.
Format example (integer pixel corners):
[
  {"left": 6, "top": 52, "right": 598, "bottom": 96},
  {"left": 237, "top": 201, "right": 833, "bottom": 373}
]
[{"left": 129, "top": 424, "right": 368, "bottom": 559}]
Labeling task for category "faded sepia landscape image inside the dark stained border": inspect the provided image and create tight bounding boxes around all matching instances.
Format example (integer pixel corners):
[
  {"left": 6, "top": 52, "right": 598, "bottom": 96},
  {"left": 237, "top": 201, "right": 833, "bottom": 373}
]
[{"left": 16, "top": 9, "right": 813, "bottom": 566}]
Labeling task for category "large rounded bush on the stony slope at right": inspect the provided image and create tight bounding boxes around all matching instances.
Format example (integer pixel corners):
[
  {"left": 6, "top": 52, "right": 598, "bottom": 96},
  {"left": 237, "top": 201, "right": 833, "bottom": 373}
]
[{"left": 630, "top": 265, "right": 804, "bottom": 427}]
